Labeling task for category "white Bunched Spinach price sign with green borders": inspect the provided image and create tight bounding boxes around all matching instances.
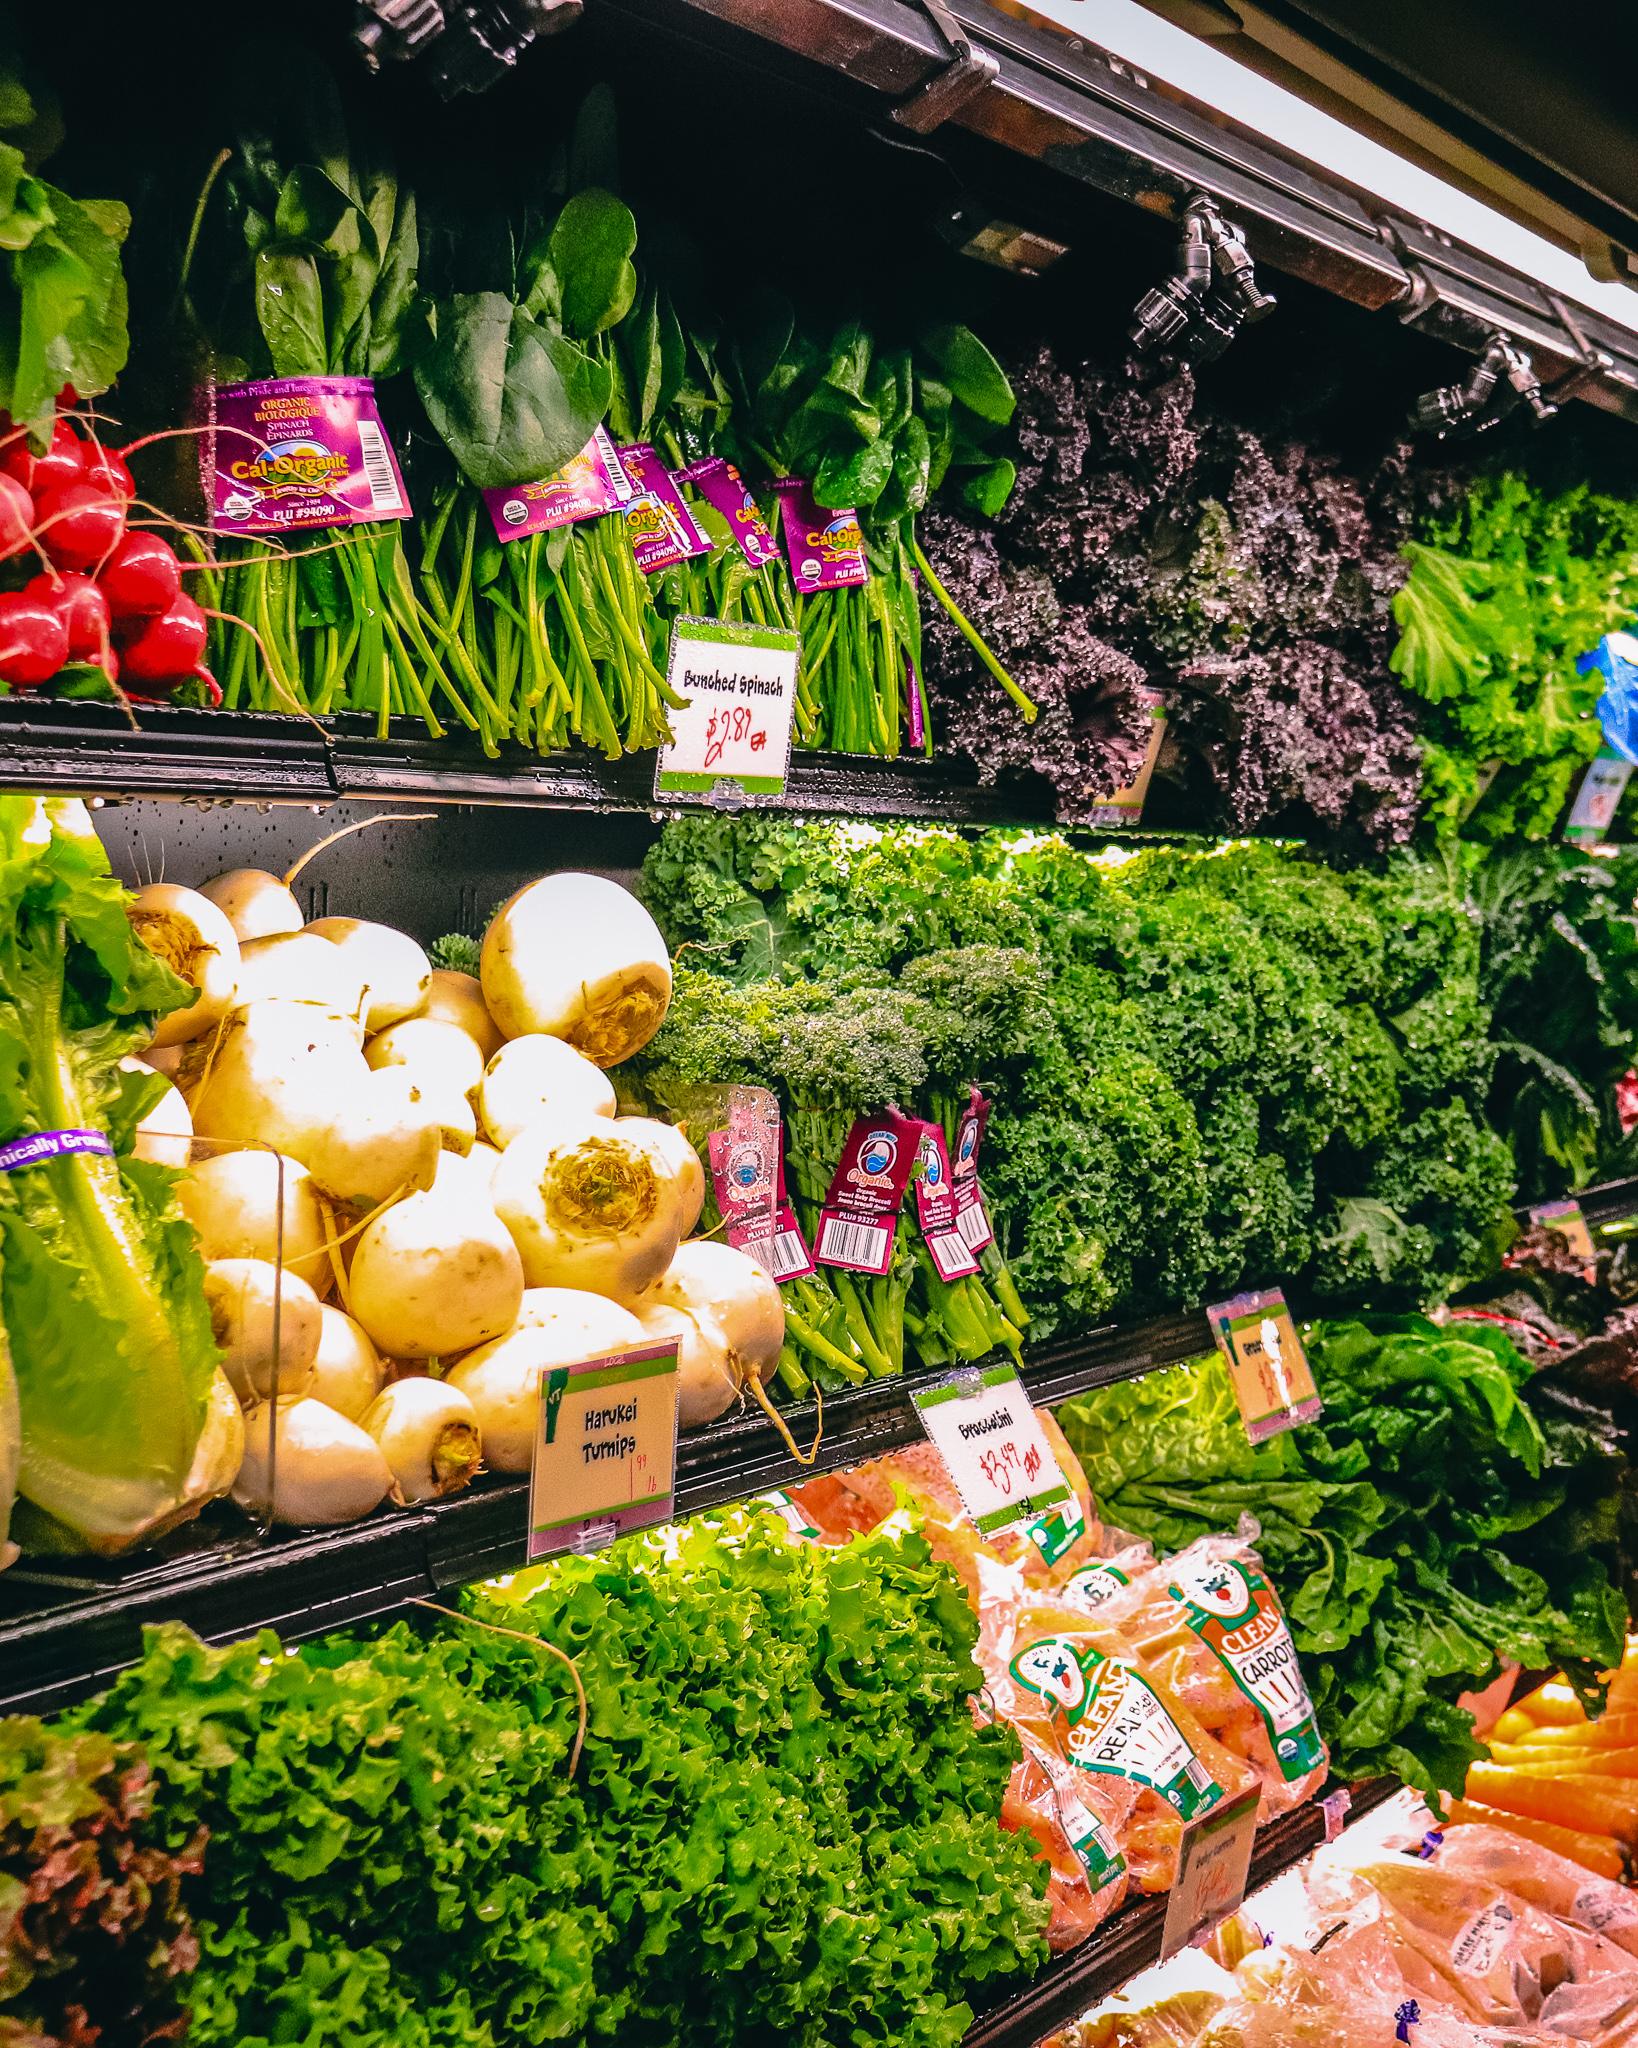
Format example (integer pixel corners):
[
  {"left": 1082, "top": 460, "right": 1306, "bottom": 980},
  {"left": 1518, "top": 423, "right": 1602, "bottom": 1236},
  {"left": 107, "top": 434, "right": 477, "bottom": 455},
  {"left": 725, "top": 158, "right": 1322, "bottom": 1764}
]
[{"left": 653, "top": 618, "right": 801, "bottom": 805}]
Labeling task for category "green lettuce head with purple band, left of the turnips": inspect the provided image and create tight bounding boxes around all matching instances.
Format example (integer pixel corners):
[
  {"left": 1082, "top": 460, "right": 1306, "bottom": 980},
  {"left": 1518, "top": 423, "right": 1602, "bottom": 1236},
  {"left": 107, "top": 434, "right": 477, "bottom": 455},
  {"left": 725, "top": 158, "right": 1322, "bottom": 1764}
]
[{"left": 0, "top": 797, "right": 217, "bottom": 1552}]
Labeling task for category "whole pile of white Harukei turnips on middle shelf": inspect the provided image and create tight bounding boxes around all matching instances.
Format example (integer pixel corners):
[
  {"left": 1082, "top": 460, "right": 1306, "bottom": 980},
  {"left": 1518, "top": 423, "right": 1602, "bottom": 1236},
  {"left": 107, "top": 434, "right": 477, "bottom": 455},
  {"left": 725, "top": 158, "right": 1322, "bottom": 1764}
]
[{"left": 127, "top": 842, "right": 784, "bottom": 1526}]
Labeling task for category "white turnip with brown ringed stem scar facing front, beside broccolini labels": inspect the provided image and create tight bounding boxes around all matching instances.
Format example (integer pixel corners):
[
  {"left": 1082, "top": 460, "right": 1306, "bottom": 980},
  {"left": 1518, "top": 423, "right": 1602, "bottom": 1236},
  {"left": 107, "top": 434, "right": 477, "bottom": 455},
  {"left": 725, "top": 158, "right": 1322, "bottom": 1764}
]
[{"left": 493, "top": 1116, "right": 684, "bottom": 1300}]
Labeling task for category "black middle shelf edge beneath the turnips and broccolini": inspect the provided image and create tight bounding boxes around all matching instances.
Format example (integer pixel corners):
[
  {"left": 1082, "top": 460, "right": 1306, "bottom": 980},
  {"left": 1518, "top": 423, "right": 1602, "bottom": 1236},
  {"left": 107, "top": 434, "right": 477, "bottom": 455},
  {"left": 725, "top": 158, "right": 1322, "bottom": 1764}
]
[{"left": 0, "top": 1315, "right": 1210, "bottom": 1712}]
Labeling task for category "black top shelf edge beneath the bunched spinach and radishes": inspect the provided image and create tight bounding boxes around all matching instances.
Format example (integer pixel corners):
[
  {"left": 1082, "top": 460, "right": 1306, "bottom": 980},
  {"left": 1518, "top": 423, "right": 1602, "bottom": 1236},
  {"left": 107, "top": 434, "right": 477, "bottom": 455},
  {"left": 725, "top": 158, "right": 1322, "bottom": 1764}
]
[{"left": 0, "top": 698, "right": 1052, "bottom": 825}]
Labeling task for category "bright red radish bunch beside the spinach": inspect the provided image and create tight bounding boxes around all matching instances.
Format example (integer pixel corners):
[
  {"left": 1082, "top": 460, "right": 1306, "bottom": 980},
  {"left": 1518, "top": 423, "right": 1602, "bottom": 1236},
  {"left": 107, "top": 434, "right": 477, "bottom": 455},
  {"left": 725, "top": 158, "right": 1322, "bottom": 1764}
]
[{"left": 0, "top": 416, "right": 221, "bottom": 702}]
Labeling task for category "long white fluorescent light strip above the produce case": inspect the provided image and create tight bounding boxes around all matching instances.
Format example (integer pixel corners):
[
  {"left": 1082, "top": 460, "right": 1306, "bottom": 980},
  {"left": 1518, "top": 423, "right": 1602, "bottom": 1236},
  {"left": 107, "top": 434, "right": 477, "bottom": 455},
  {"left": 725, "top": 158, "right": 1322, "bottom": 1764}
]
[{"left": 1011, "top": 0, "right": 1638, "bottom": 334}]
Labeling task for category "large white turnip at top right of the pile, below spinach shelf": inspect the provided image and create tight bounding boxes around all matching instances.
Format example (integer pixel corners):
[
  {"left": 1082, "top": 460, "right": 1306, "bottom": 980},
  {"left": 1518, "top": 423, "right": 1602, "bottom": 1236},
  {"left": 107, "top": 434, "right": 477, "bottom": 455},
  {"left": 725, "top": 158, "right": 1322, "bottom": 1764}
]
[{"left": 479, "top": 874, "right": 672, "bottom": 1067}]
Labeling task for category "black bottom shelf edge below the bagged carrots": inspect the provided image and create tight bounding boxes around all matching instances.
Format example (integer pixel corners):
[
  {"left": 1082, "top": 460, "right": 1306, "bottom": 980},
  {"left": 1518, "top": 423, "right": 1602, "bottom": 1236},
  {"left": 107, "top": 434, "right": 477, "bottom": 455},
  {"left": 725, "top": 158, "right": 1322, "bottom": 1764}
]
[{"left": 962, "top": 1778, "right": 1398, "bottom": 2048}]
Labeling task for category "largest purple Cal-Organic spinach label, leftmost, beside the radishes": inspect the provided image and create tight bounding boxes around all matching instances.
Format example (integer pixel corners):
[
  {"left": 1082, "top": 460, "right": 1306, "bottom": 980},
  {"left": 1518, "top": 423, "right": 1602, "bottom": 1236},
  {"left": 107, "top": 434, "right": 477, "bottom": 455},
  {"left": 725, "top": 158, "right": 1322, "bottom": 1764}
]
[{"left": 203, "top": 377, "right": 410, "bottom": 532}]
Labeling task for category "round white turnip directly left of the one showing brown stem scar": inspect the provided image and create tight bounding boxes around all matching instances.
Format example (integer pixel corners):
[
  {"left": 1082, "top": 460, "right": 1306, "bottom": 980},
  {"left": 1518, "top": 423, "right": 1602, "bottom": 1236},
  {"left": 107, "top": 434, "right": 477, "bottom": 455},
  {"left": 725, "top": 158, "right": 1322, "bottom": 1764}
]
[{"left": 348, "top": 1190, "right": 524, "bottom": 1358}]
